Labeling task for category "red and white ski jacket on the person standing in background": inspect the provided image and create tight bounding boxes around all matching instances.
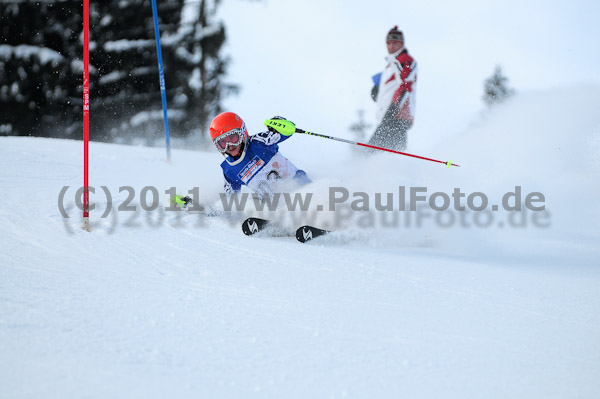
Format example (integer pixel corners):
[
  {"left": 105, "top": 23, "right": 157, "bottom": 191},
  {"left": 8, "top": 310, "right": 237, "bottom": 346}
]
[{"left": 375, "top": 48, "right": 417, "bottom": 123}]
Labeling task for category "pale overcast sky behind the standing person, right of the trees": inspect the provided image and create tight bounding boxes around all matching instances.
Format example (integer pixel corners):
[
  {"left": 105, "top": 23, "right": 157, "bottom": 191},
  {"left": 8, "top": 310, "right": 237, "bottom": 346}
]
[{"left": 218, "top": 0, "right": 600, "bottom": 152}]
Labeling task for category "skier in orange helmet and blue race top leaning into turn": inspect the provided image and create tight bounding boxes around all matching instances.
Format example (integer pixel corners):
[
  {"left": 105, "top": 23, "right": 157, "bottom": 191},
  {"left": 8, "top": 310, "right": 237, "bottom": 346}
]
[{"left": 210, "top": 112, "right": 311, "bottom": 196}]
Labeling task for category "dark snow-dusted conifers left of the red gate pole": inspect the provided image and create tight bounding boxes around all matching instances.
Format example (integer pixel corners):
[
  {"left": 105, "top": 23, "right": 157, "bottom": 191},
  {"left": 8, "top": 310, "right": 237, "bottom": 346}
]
[{"left": 0, "top": 1, "right": 83, "bottom": 137}]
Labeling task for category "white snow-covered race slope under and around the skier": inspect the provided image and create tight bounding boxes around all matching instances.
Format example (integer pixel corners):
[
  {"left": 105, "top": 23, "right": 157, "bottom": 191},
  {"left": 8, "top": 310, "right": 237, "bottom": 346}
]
[{"left": 0, "top": 88, "right": 600, "bottom": 398}]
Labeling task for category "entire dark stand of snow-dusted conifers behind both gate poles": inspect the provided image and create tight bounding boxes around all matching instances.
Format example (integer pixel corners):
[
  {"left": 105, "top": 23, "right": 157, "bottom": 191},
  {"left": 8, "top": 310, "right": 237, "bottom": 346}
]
[{"left": 0, "top": 0, "right": 236, "bottom": 142}]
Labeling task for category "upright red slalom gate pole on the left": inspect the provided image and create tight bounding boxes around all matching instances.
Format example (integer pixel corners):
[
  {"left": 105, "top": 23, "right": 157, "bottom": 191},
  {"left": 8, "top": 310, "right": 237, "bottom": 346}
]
[{"left": 83, "top": 0, "right": 90, "bottom": 231}]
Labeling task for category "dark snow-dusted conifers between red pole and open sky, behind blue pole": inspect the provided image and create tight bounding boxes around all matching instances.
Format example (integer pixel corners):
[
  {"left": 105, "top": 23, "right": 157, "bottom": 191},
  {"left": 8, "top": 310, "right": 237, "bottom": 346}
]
[{"left": 91, "top": 0, "right": 235, "bottom": 144}]
